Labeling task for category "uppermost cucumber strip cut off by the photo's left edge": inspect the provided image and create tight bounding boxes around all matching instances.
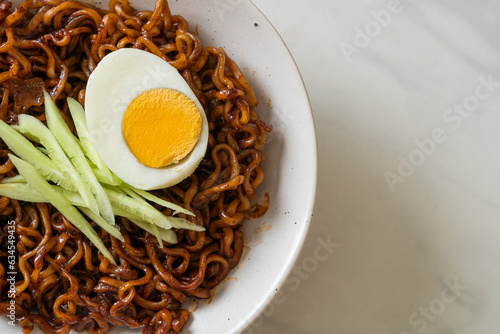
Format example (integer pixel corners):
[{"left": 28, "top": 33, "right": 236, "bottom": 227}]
[{"left": 0, "top": 120, "right": 75, "bottom": 190}]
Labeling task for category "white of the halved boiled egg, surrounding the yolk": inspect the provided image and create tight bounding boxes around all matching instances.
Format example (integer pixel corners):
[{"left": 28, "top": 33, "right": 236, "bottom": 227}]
[{"left": 85, "top": 49, "right": 208, "bottom": 190}]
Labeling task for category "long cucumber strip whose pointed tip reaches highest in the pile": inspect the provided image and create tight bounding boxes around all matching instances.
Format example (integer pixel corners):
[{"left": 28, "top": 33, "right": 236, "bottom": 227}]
[{"left": 43, "top": 91, "right": 115, "bottom": 225}]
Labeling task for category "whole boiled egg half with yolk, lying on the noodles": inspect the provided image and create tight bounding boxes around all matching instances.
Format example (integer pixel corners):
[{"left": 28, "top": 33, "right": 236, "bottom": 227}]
[{"left": 85, "top": 49, "right": 208, "bottom": 190}]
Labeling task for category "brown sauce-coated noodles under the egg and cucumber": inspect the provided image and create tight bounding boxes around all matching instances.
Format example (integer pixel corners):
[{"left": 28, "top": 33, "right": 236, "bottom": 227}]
[{"left": 0, "top": 0, "right": 271, "bottom": 334}]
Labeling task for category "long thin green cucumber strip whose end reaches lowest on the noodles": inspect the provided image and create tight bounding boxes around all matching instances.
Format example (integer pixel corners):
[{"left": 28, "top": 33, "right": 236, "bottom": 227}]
[{"left": 9, "top": 154, "right": 116, "bottom": 264}]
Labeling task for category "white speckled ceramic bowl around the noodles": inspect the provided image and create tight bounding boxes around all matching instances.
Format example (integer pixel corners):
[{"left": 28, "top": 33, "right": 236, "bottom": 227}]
[{"left": 0, "top": 0, "right": 317, "bottom": 334}]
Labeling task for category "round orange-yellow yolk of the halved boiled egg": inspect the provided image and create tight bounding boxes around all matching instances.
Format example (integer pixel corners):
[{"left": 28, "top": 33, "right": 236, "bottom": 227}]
[{"left": 122, "top": 88, "right": 202, "bottom": 168}]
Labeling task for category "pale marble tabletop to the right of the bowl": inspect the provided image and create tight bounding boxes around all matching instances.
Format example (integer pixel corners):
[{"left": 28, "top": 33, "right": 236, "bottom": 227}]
[{"left": 249, "top": 0, "right": 500, "bottom": 334}]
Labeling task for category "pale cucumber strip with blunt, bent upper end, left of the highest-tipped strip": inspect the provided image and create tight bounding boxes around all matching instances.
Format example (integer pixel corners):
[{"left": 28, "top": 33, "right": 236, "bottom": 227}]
[{"left": 19, "top": 115, "right": 99, "bottom": 215}]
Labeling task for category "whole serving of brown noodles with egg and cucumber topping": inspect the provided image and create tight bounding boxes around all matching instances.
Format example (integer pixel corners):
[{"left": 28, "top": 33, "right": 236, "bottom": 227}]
[{"left": 0, "top": 0, "right": 271, "bottom": 333}]
